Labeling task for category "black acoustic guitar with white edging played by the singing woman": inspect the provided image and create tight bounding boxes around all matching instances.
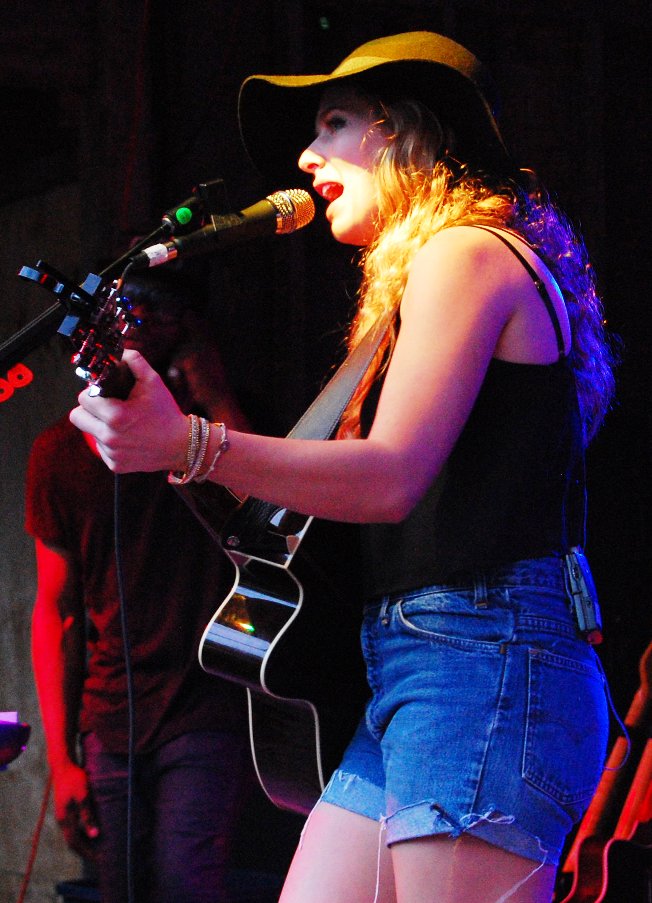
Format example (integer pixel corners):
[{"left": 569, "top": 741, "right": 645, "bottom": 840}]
[{"left": 19, "top": 261, "right": 368, "bottom": 814}]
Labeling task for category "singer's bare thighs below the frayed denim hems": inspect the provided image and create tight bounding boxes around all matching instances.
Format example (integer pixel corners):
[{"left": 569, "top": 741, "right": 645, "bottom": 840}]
[{"left": 279, "top": 802, "right": 555, "bottom": 903}]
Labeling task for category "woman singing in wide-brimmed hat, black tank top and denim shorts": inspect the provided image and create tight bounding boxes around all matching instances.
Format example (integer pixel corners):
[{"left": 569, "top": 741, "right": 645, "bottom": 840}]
[{"left": 71, "top": 32, "right": 613, "bottom": 903}]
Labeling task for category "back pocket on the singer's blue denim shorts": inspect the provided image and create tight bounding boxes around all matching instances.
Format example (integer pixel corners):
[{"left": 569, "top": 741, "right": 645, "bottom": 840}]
[{"left": 523, "top": 649, "right": 608, "bottom": 820}]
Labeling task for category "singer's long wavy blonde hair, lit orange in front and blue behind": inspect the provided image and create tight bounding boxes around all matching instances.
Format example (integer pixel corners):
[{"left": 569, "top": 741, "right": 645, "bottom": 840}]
[{"left": 338, "top": 100, "right": 614, "bottom": 441}]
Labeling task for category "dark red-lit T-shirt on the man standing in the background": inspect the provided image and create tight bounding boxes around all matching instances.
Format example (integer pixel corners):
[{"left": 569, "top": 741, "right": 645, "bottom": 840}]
[{"left": 26, "top": 417, "right": 246, "bottom": 752}]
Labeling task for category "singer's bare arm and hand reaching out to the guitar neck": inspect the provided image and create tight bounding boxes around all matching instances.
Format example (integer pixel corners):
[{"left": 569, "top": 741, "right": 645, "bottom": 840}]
[{"left": 71, "top": 228, "right": 530, "bottom": 522}]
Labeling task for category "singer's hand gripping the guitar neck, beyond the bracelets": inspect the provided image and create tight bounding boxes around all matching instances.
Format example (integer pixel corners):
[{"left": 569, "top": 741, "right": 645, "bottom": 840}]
[{"left": 70, "top": 351, "right": 188, "bottom": 473}]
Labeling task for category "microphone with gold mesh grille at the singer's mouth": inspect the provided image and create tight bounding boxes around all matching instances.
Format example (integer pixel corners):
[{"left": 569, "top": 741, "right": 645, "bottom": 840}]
[{"left": 131, "top": 188, "right": 315, "bottom": 269}]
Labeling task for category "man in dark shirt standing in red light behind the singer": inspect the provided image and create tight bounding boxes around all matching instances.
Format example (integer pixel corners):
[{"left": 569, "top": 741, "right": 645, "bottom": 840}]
[{"left": 26, "top": 272, "right": 250, "bottom": 903}]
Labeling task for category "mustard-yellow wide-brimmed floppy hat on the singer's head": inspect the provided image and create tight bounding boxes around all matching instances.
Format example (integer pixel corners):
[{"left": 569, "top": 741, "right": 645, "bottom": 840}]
[{"left": 238, "top": 32, "right": 515, "bottom": 185}]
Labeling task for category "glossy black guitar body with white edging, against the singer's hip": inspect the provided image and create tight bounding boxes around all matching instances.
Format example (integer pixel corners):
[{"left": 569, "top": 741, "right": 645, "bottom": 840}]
[{"left": 199, "top": 503, "right": 368, "bottom": 814}]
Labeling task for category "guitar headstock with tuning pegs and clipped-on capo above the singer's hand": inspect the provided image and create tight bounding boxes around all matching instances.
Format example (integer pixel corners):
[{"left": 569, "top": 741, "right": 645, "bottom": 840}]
[{"left": 18, "top": 260, "right": 139, "bottom": 398}]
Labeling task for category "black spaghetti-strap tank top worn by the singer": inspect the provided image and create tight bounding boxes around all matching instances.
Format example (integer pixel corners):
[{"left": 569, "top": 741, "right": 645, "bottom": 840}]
[{"left": 362, "top": 229, "right": 582, "bottom": 598}]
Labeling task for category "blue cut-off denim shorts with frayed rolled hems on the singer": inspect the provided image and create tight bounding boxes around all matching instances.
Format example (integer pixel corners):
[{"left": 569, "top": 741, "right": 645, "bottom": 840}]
[{"left": 322, "top": 558, "right": 609, "bottom": 865}]
